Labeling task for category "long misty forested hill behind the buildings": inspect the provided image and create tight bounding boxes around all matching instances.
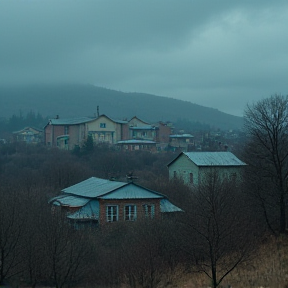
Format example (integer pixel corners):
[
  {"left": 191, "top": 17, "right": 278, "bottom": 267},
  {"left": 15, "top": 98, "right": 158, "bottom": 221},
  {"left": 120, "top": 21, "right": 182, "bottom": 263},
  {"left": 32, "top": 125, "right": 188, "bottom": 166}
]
[{"left": 0, "top": 84, "right": 243, "bottom": 129}]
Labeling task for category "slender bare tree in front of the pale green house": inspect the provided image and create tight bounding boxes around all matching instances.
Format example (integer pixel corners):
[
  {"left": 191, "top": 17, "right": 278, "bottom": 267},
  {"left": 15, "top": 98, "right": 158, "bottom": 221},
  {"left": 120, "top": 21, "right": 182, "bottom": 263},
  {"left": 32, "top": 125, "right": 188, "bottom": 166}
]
[{"left": 180, "top": 170, "right": 257, "bottom": 288}]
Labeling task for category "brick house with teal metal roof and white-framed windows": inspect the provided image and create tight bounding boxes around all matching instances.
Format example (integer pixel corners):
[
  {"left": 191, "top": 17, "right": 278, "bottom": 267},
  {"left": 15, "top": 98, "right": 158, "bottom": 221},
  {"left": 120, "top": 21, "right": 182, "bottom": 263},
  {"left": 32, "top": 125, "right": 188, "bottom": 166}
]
[{"left": 49, "top": 177, "right": 182, "bottom": 225}]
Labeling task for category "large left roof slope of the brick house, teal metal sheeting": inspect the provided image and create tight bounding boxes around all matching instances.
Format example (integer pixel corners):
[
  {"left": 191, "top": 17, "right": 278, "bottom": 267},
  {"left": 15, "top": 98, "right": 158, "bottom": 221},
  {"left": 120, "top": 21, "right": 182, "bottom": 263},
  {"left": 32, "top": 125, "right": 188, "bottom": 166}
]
[{"left": 62, "top": 177, "right": 127, "bottom": 198}]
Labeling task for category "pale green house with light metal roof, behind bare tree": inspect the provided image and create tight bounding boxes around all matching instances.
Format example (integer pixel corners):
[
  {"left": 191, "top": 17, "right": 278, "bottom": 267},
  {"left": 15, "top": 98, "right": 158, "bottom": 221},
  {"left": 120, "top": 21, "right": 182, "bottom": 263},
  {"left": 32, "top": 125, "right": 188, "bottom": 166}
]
[{"left": 167, "top": 152, "right": 246, "bottom": 185}]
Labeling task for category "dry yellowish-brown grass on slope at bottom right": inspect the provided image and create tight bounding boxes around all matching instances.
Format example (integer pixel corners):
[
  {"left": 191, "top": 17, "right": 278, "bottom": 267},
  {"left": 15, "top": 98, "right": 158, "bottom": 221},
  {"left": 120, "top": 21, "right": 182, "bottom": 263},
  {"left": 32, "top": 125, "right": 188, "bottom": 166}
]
[{"left": 172, "top": 236, "right": 288, "bottom": 288}]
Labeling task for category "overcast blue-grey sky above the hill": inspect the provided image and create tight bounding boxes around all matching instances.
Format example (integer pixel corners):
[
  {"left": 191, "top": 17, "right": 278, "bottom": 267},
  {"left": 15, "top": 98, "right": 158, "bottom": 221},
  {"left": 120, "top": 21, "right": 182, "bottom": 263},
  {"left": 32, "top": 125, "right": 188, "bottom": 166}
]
[{"left": 0, "top": 0, "right": 288, "bottom": 116}]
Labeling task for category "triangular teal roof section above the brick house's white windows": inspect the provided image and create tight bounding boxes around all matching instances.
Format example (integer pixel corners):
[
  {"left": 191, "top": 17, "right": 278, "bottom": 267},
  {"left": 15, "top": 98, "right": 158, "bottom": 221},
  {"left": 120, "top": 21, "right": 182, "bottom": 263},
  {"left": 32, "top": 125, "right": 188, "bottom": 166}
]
[{"left": 99, "top": 183, "right": 164, "bottom": 199}]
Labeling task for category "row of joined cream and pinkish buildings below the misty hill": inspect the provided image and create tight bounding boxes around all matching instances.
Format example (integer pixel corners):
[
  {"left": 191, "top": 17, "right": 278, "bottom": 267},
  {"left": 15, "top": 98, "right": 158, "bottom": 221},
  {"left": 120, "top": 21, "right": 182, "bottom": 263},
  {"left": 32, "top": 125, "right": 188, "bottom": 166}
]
[{"left": 44, "top": 115, "right": 172, "bottom": 151}]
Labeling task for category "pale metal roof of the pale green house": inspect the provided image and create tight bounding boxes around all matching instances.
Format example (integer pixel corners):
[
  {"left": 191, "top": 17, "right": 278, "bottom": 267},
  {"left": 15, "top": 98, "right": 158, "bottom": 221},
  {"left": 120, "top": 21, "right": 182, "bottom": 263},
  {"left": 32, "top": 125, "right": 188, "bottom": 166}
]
[{"left": 183, "top": 152, "right": 246, "bottom": 166}]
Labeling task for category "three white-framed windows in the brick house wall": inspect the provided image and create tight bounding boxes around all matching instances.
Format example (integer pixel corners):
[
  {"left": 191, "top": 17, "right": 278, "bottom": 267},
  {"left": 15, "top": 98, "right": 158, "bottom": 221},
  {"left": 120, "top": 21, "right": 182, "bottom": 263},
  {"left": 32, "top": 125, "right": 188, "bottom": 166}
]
[{"left": 106, "top": 204, "right": 155, "bottom": 222}]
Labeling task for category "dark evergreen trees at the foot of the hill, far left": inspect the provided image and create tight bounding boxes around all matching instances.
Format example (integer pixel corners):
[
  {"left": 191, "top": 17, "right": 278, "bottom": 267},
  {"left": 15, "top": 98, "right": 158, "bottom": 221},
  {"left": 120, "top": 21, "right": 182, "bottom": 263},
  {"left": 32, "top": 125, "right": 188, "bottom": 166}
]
[{"left": 0, "top": 111, "right": 48, "bottom": 138}]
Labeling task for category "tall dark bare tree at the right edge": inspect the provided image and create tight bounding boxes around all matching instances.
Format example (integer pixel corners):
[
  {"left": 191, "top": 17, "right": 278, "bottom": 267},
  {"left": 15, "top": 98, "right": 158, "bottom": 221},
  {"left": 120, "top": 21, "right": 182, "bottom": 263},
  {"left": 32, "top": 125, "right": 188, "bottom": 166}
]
[{"left": 244, "top": 95, "right": 288, "bottom": 233}]
